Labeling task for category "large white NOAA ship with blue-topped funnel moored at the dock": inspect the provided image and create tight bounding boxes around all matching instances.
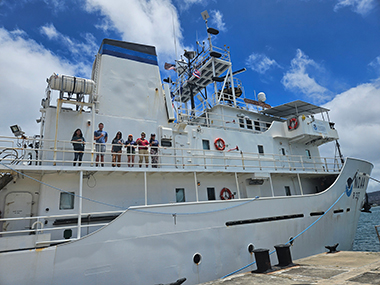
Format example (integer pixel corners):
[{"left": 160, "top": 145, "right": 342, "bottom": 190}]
[{"left": 0, "top": 12, "right": 373, "bottom": 285}]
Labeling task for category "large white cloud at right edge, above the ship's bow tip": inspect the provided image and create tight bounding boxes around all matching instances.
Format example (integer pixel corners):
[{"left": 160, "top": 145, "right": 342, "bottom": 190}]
[{"left": 324, "top": 79, "right": 380, "bottom": 191}]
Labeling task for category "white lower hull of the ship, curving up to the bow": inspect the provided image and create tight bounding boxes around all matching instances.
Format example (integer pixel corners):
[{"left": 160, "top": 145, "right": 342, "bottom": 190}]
[{"left": 0, "top": 156, "right": 372, "bottom": 285}]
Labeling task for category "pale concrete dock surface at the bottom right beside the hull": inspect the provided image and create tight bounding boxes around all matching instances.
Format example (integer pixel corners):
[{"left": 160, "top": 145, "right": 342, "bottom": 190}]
[{"left": 203, "top": 251, "right": 380, "bottom": 285}]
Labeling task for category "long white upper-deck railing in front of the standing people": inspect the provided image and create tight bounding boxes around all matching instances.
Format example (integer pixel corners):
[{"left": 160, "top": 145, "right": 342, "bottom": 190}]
[{"left": 0, "top": 135, "right": 342, "bottom": 172}]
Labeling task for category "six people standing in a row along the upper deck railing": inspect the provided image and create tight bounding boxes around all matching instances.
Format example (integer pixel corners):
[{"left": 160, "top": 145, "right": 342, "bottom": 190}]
[{"left": 71, "top": 123, "right": 159, "bottom": 168}]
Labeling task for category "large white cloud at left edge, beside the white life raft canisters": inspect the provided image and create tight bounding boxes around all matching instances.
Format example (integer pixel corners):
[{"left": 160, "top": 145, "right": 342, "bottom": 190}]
[{"left": 0, "top": 28, "right": 81, "bottom": 136}]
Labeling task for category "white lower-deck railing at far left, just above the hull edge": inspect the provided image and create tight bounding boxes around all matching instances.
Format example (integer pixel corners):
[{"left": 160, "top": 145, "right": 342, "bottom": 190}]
[{"left": 0, "top": 210, "right": 124, "bottom": 248}]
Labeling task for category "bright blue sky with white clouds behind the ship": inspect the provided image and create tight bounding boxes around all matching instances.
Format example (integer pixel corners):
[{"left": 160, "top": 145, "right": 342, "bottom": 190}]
[{"left": 0, "top": 0, "right": 380, "bottom": 189}]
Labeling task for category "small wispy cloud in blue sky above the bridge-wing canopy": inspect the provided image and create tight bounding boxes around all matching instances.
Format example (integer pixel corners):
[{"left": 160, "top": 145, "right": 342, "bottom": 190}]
[{"left": 281, "top": 49, "right": 331, "bottom": 104}]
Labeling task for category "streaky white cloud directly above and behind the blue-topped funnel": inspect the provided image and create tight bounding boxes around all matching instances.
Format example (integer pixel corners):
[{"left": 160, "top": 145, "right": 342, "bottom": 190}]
[{"left": 86, "top": 0, "right": 182, "bottom": 60}]
